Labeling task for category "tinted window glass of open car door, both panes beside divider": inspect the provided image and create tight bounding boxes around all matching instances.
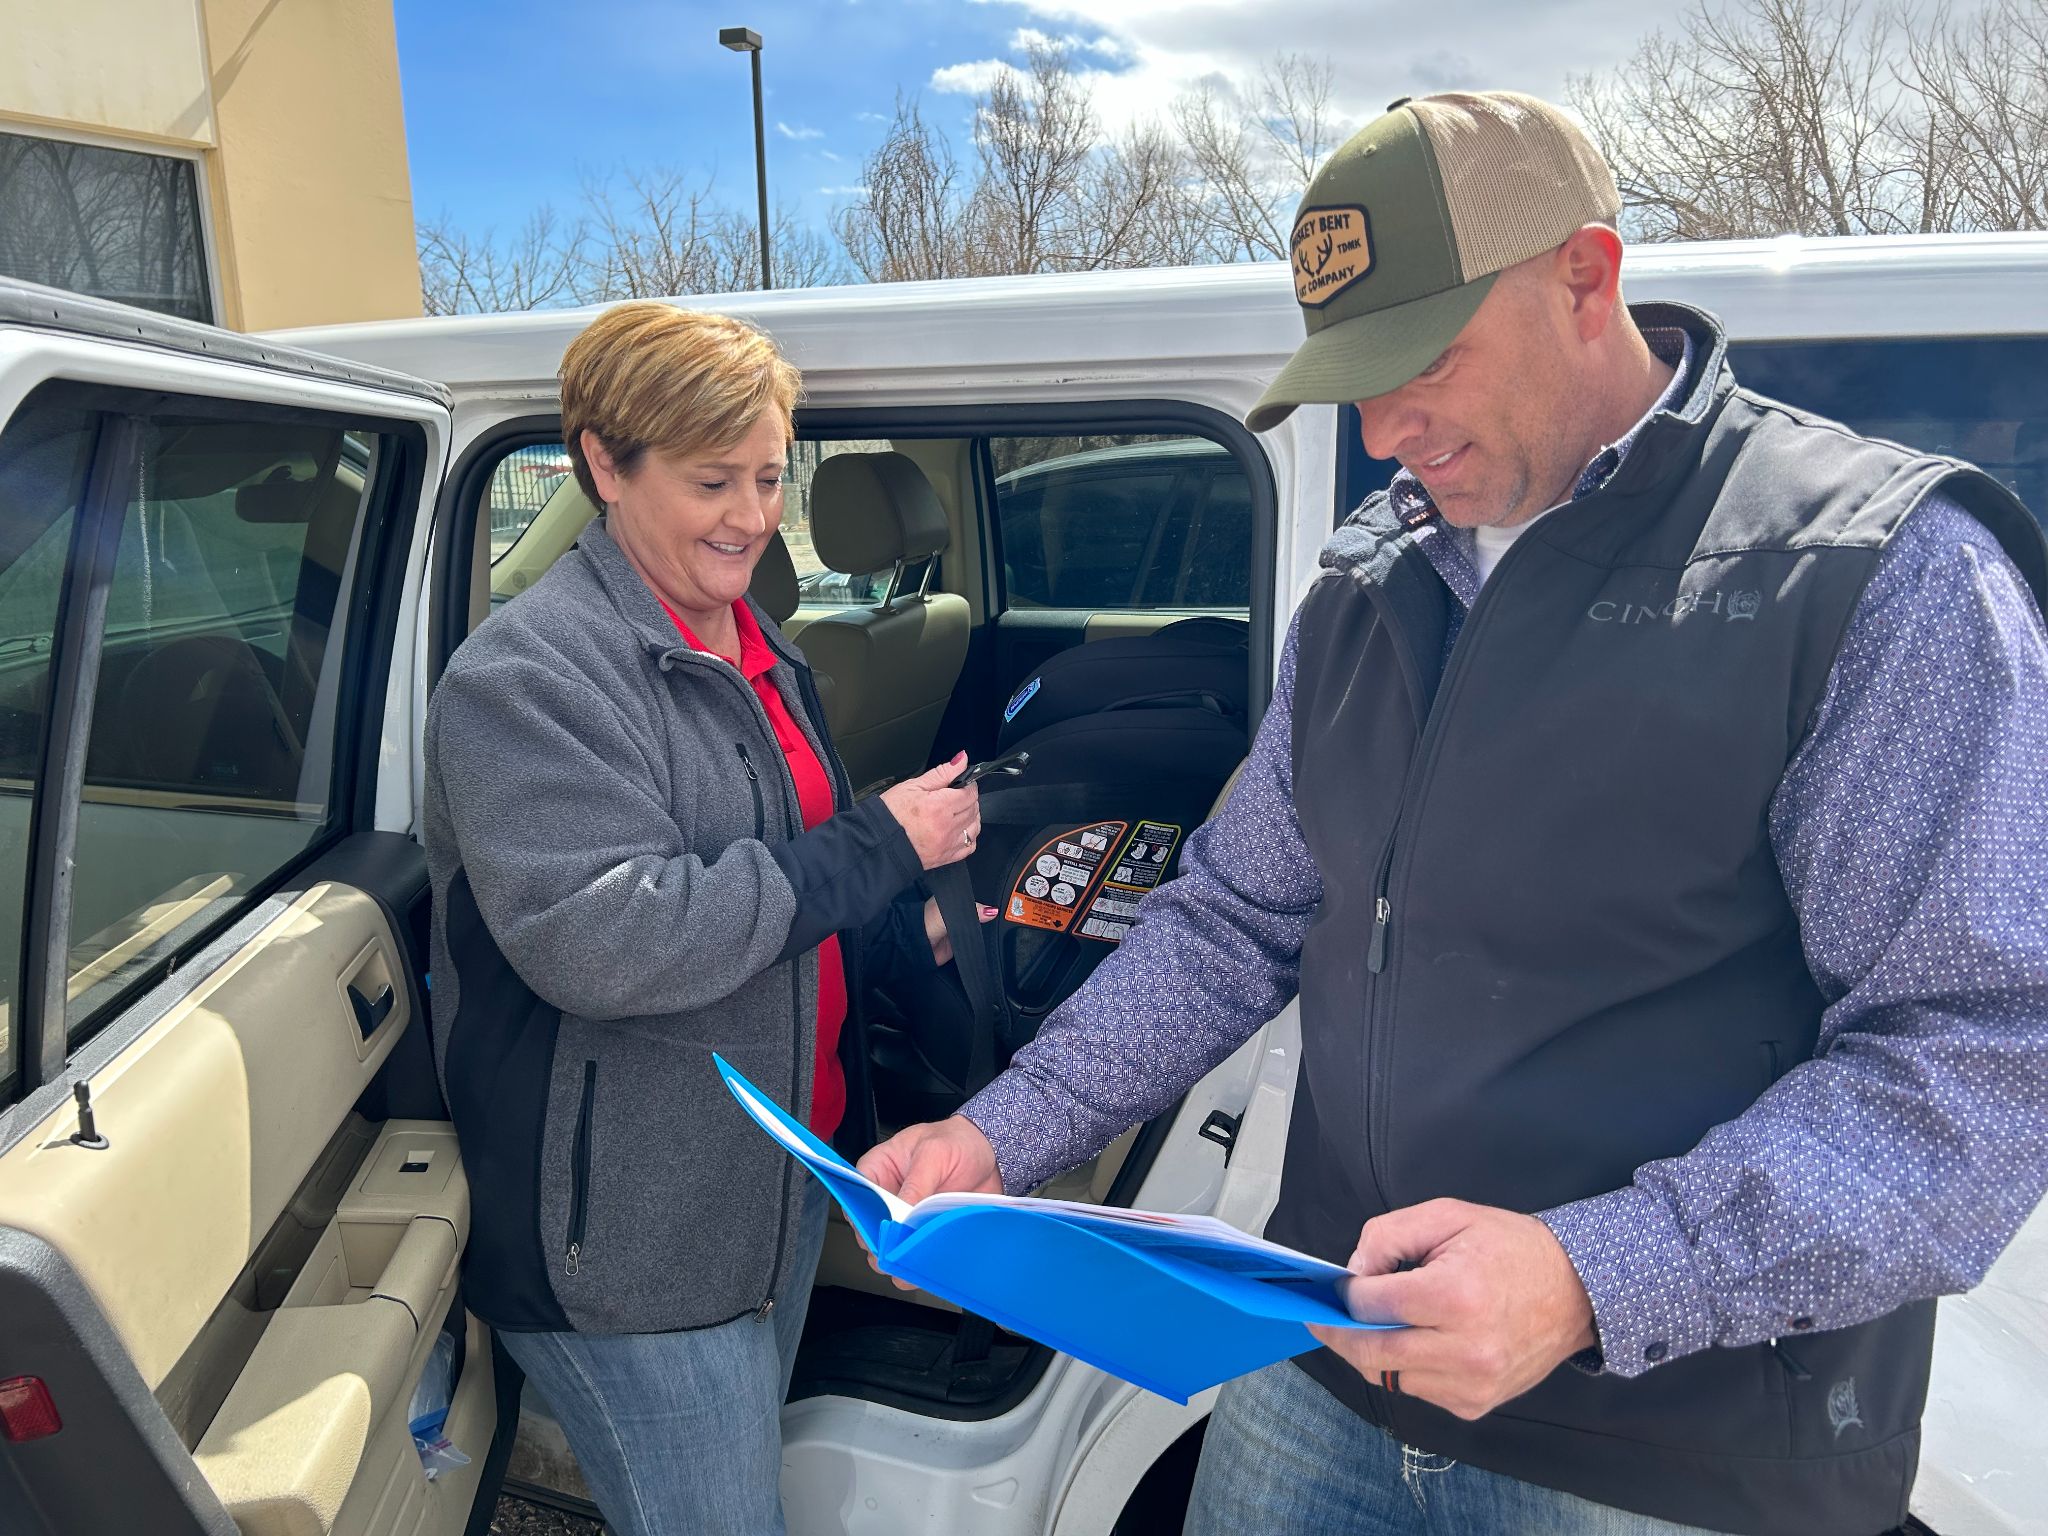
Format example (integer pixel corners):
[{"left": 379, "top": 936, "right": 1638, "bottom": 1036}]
[{"left": 0, "top": 397, "right": 395, "bottom": 1056}]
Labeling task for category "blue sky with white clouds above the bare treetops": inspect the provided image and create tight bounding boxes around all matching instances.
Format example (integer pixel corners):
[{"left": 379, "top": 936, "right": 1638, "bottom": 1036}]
[{"left": 395, "top": 0, "right": 1677, "bottom": 243}]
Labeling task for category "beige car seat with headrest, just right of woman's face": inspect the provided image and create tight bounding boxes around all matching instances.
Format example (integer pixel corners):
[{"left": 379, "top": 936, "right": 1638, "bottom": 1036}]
[{"left": 797, "top": 453, "right": 971, "bottom": 793}]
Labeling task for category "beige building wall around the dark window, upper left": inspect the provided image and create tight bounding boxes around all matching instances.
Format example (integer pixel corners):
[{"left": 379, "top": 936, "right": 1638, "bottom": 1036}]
[{"left": 0, "top": 0, "right": 420, "bottom": 330}]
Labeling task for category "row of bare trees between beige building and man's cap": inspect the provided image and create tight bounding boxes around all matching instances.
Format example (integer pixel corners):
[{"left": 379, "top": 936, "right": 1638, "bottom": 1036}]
[{"left": 420, "top": 39, "right": 1346, "bottom": 303}]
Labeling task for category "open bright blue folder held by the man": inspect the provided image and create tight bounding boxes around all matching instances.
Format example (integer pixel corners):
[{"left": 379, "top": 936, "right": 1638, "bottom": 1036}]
[{"left": 713, "top": 1057, "right": 1399, "bottom": 1403}]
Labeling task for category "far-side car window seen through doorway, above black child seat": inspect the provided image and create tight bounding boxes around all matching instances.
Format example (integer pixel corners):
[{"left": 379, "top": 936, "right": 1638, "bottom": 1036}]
[{"left": 989, "top": 434, "right": 1251, "bottom": 610}]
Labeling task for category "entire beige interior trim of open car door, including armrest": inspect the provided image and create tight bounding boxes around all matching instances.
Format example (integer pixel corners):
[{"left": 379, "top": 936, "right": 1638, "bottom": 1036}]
[{"left": 0, "top": 856, "right": 483, "bottom": 1532}]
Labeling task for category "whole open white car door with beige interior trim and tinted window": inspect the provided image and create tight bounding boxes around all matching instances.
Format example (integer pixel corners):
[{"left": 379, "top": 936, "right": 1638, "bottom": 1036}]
[{"left": 0, "top": 301, "right": 499, "bottom": 1536}]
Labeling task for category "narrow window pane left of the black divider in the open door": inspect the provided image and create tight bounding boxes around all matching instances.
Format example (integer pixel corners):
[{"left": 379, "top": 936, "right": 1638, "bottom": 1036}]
[{"left": 0, "top": 406, "right": 96, "bottom": 1102}]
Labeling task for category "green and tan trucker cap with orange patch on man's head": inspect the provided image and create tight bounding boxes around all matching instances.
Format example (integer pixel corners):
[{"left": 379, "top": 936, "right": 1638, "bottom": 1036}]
[{"left": 1245, "top": 90, "right": 1622, "bottom": 432}]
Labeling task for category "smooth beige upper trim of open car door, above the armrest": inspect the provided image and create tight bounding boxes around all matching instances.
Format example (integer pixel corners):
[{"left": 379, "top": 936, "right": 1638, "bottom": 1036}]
[{"left": 0, "top": 883, "right": 412, "bottom": 1389}]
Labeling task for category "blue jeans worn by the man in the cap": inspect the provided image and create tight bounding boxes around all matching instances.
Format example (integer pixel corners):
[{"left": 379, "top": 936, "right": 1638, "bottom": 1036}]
[{"left": 1184, "top": 1360, "right": 1728, "bottom": 1536}]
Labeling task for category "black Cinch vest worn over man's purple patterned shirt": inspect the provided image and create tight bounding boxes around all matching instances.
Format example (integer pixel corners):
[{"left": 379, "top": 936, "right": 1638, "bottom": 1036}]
[{"left": 1268, "top": 305, "right": 2048, "bottom": 1536}]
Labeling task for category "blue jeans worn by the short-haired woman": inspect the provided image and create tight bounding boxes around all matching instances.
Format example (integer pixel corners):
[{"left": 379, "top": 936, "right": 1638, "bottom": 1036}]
[{"left": 502, "top": 1174, "right": 831, "bottom": 1536}]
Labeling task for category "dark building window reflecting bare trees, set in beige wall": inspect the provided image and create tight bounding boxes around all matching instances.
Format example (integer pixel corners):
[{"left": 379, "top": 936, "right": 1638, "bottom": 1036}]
[{"left": 0, "top": 133, "right": 213, "bottom": 322}]
